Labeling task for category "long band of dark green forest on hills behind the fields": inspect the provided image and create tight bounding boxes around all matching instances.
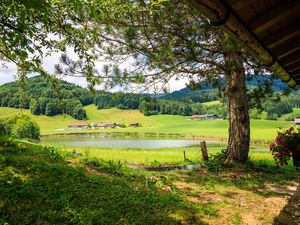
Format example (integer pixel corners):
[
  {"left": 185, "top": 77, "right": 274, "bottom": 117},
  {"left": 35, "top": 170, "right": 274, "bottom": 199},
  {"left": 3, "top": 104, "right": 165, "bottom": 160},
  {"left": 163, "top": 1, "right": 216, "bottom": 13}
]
[{"left": 0, "top": 76, "right": 226, "bottom": 120}]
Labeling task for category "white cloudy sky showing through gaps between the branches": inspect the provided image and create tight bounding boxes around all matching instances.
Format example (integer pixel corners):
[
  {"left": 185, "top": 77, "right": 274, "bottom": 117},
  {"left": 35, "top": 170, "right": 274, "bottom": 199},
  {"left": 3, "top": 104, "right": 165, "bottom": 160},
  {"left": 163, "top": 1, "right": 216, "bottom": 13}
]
[{"left": 0, "top": 50, "right": 186, "bottom": 92}]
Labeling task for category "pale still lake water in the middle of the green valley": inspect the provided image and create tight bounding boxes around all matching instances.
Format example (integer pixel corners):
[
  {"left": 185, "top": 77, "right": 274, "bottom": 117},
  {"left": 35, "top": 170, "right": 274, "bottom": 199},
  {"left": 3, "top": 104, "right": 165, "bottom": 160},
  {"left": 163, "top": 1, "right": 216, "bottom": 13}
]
[{"left": 41, "top": 133, "right": 200, "bottom": 148}]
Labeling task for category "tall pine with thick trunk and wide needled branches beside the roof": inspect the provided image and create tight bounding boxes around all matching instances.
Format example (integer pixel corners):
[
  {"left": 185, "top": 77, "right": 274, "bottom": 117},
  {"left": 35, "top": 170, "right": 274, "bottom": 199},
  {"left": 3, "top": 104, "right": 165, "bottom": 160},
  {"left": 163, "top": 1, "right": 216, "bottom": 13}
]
[{"left": 56, "top": 0, "right": 272, "bottom": 162}]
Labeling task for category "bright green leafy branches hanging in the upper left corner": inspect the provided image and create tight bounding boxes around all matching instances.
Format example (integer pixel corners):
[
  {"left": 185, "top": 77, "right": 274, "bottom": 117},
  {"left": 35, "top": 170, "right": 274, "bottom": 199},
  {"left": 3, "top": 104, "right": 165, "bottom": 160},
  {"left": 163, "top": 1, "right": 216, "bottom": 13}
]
[{"left": 0, "top": 0, "right": 92, "bottom": 79}]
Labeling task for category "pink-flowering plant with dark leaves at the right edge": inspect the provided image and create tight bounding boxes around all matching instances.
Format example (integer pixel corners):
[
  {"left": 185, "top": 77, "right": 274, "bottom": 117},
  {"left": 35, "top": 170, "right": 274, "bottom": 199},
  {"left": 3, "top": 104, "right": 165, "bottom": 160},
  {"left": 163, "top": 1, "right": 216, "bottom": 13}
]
[{"left": 270, "top": 127, "right": 300, "bottom": 166}]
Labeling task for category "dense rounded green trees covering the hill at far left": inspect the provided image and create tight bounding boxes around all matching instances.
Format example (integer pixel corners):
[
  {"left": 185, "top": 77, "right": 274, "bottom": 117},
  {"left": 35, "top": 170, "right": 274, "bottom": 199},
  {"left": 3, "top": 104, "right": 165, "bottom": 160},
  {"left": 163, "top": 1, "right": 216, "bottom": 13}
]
[{"left": 0, "top": 76, "right": 89, "bottom": 120}]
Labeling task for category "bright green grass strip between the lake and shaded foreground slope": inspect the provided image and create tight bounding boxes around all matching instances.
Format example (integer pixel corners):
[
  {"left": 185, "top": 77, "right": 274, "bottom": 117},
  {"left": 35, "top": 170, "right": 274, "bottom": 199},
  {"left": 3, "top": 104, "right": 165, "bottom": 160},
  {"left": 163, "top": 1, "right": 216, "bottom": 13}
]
[{"left": 51, "top": 143, "right": 273, "bottom": 165}]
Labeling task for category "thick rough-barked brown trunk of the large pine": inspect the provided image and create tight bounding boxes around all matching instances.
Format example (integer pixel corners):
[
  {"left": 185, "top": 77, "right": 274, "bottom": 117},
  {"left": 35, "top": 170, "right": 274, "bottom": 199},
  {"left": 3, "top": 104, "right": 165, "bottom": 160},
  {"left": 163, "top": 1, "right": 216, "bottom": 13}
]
[{"left": 224, "top": 50, "right": 250, "bottom": 163}]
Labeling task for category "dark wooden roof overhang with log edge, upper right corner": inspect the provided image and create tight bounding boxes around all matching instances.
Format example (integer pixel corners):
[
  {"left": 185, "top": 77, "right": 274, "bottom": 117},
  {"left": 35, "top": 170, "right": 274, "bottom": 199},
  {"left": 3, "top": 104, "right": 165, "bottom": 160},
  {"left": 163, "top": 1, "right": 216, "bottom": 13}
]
[{"left": 193, "top": 0, "right": 300, "bottom": 89}]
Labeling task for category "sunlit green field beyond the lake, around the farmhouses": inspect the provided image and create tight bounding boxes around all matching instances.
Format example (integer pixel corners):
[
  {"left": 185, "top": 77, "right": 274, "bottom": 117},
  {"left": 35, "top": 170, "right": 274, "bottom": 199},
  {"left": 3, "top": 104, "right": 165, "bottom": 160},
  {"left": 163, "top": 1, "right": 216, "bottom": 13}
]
[{"left": 0, "top": 105, "right": 293, "bottom": 140}]
